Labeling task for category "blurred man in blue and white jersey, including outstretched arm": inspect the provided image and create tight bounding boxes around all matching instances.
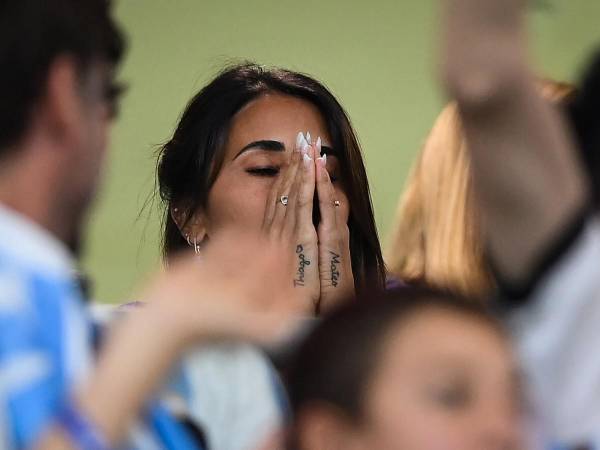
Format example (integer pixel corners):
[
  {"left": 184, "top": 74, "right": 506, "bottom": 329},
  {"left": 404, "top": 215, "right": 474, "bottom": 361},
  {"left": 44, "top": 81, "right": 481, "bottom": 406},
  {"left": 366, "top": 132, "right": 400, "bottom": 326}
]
[{"left": 0, "top": 0, "right": 296, "bottom": 449}]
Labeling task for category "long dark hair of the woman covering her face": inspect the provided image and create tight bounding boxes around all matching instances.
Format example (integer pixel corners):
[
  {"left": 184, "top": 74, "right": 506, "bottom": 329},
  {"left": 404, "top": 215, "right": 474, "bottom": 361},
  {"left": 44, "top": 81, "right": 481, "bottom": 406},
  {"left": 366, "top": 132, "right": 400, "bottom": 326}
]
[{"left": 157, "top": 63, "right": 385, "bottom": 291}]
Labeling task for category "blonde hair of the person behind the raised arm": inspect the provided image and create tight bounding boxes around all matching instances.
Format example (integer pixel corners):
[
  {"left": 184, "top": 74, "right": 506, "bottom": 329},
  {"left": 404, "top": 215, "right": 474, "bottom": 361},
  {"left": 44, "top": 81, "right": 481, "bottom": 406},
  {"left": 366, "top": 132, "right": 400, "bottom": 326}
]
[{"left": 387, "top": 80, "right": 574, "bottom": 298}]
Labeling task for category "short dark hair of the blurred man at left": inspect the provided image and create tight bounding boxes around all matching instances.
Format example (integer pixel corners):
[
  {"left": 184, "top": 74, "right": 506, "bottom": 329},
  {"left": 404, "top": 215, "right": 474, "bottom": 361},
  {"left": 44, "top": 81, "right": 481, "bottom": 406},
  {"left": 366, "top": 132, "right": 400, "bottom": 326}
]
[{"left": 0, "top": 0, "right": 125, "bottom": 153}]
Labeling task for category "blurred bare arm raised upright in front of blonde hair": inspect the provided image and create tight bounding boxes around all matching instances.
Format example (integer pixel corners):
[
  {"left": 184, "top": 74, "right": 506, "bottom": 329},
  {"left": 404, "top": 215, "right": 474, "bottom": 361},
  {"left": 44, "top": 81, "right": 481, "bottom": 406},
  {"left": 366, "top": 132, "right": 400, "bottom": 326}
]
[{"left": 441, "top": 0, "right": 588, "bottom": 287}]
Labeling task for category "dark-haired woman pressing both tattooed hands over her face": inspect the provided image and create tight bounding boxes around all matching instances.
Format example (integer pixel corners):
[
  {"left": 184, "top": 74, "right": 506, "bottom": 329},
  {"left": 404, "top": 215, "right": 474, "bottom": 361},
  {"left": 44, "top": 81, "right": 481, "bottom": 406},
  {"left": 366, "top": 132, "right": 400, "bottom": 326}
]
[{"left": 157, "top": 64, "right": 385, "bottom": 313}]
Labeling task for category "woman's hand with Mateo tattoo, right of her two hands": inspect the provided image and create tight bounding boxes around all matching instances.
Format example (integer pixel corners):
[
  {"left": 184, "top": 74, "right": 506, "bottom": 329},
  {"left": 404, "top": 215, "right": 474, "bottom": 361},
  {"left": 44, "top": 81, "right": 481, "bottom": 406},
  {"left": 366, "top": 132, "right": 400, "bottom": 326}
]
[{"left": 314, "top": 138, "right": 354, "bottom": 311}]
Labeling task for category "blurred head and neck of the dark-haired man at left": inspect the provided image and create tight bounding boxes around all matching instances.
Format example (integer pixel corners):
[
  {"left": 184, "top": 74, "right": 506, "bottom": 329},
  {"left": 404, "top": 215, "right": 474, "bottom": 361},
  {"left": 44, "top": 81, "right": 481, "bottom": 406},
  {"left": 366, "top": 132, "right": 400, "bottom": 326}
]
[{"left": 0, "top": 0, "right": 124, "bottom": 252}]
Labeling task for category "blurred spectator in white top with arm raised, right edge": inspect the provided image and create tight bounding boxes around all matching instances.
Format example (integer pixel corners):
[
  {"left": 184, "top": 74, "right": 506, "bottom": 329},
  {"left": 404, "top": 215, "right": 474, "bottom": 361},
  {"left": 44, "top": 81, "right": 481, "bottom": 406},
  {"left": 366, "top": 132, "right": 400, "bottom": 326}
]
[{"left": 442, "top": 0, "right": 600, "bottom": 448}]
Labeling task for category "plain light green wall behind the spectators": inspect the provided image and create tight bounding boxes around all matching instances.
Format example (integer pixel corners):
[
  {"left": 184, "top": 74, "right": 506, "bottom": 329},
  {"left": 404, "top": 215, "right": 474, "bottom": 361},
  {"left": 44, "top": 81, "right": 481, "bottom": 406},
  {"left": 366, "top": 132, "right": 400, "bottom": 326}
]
[{"left": 84, "top": 0, "right": 600, "bottom": 303}]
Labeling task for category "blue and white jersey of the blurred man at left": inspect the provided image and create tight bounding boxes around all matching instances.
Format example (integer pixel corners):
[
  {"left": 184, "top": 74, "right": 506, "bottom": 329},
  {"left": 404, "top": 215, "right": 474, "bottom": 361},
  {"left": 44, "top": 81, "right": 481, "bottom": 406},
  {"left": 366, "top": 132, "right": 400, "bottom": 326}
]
[{"left": 0, "top": 205, "right": 198, "bottom": 450}]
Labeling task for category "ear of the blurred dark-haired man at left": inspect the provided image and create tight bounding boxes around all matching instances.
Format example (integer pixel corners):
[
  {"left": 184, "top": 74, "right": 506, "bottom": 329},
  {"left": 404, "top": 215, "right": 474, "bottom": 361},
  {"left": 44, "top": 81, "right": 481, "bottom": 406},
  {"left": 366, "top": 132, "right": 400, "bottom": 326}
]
[{"left": 41, "top": 56, "right": 83, "bottom": 143}]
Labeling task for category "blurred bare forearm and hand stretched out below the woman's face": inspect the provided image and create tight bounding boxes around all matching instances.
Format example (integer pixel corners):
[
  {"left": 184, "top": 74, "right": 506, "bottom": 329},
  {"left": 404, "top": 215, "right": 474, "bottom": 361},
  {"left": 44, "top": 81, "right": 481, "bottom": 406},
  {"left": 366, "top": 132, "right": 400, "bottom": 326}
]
[{"left": 38, "top": 235, "right": 299, "bottom": 450}]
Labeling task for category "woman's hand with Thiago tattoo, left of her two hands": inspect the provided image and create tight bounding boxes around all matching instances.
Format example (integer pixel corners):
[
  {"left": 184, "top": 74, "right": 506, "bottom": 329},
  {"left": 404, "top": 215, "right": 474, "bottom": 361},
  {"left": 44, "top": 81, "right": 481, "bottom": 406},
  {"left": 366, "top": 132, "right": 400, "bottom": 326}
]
[{"left": 263, "top": 133, "right": 320, "bottom": 313}]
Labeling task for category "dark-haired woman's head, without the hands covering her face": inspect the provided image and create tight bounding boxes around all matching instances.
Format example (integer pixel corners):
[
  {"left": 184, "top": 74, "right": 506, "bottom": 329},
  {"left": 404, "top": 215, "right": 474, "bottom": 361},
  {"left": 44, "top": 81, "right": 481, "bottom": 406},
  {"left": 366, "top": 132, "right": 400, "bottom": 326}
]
[{"left": 158, "top": 63, "right": 384, "bottom": 302}]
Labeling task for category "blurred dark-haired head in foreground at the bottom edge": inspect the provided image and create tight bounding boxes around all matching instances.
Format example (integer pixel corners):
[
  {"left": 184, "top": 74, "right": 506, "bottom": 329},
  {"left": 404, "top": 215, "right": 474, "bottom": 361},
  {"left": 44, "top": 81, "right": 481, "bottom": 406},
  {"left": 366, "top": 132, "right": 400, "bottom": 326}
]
[{"left": 289, "top": 288, "right": 522, "bottom": 450}]
